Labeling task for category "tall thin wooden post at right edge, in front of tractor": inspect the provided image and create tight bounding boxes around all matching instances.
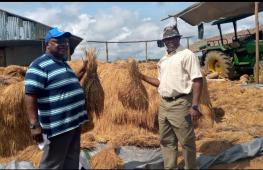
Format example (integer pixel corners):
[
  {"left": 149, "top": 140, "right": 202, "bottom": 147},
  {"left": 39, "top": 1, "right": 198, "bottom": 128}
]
[{"left": 254, "top": 2, "right": 259, "bottom": 84}]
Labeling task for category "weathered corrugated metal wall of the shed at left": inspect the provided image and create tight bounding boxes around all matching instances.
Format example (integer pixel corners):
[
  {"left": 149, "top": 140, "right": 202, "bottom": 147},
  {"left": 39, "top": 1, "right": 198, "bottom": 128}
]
[{"left": 0, "top": 10, "right": 49, "bottom": 40}]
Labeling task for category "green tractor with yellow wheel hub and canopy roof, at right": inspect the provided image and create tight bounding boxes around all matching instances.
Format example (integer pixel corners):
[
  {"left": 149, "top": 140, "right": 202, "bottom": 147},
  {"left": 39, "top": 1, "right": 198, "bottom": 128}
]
[{"left": 199, "top": 15, "right": 263, "bottom": 80}]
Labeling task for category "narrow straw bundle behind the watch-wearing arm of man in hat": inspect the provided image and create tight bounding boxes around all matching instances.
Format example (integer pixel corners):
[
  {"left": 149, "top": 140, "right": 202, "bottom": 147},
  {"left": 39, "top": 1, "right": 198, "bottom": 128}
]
[{"left": 196, "top": 74, "right": 215, "bottom": 128}]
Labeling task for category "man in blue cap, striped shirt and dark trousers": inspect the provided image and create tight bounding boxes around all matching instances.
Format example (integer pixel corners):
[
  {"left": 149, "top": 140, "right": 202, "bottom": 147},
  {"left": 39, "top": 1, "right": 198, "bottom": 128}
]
[{"left": 25, "top": 28, "right": 87, "bottom": 169}]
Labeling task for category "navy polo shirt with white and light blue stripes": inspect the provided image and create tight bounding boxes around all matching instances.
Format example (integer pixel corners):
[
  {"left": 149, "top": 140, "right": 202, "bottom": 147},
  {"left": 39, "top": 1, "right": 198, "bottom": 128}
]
[{"left": 25, "top": 54, "right": 87, "bottom": 138}]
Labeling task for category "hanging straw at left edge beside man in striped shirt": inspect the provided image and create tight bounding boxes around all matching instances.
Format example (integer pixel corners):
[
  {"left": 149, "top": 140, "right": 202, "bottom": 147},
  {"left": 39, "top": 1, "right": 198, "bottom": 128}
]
[{"left": 0, "top": 81, "right": 33, "bottom": 156}]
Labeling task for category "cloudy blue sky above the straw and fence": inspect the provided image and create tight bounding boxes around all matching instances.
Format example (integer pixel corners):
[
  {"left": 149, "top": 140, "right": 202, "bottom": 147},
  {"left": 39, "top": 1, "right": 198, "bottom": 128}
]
[{"left": 0, "top": 2, "right": 263, "bottom": 61}]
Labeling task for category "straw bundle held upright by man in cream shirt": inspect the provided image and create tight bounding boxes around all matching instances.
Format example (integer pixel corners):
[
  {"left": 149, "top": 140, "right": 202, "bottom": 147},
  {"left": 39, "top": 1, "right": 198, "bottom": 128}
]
[{"left": 118, "top": 58, "right": 149, "bottom": 110}]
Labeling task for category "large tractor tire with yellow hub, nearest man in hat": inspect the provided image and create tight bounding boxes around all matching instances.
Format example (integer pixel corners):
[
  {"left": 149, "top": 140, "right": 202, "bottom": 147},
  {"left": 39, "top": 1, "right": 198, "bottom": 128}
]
[{"left": 205, "top": 51, "right": 237, "bottom": 79}]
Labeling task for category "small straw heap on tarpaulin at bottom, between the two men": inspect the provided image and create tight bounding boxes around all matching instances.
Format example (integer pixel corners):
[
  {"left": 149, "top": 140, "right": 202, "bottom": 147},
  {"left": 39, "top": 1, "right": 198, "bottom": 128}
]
[{"left": 90, "top": 145, "right": 124, "bottom": 169}]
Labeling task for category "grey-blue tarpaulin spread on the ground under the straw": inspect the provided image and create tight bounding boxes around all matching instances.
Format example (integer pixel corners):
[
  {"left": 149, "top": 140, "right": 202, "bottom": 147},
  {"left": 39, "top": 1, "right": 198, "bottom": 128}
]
[{"left": 0, "top": 137, "right": 263, "bottom": 169}]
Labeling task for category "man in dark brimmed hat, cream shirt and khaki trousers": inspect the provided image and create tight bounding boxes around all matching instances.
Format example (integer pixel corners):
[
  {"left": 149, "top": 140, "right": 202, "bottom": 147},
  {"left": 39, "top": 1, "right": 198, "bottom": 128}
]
[{"left": 140, "top": 25, "right": 202, "bottom": 169}]
